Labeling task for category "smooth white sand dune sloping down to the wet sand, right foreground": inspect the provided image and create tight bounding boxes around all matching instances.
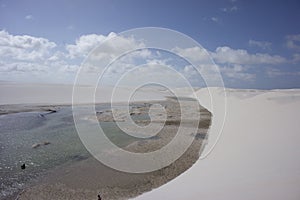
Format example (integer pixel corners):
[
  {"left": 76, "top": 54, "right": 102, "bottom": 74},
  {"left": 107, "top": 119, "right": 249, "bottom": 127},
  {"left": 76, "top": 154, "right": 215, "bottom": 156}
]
[{"left": 136, "top": 88, "right": 300, "bottom": 200}]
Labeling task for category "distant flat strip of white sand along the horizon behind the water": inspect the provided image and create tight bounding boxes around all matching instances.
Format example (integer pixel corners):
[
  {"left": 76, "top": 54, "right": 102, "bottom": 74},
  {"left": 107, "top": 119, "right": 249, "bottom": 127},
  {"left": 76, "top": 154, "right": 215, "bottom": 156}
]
[{"left": 0, "top": 82, "right": 195, "bottom": 105}]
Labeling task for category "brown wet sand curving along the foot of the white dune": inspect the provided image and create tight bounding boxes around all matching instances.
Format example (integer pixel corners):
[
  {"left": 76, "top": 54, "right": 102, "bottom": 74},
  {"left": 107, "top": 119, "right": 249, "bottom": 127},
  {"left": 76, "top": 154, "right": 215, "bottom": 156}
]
[{"left": 17, "top": 100, "right": 211, "bottom": 200}]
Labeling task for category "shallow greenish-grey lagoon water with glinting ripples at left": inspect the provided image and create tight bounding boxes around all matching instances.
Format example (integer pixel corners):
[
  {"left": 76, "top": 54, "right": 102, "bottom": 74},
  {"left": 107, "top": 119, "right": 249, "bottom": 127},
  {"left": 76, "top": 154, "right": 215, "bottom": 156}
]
[{"left": 0, "top": 105, "right": 133, "bottom": 199}]
